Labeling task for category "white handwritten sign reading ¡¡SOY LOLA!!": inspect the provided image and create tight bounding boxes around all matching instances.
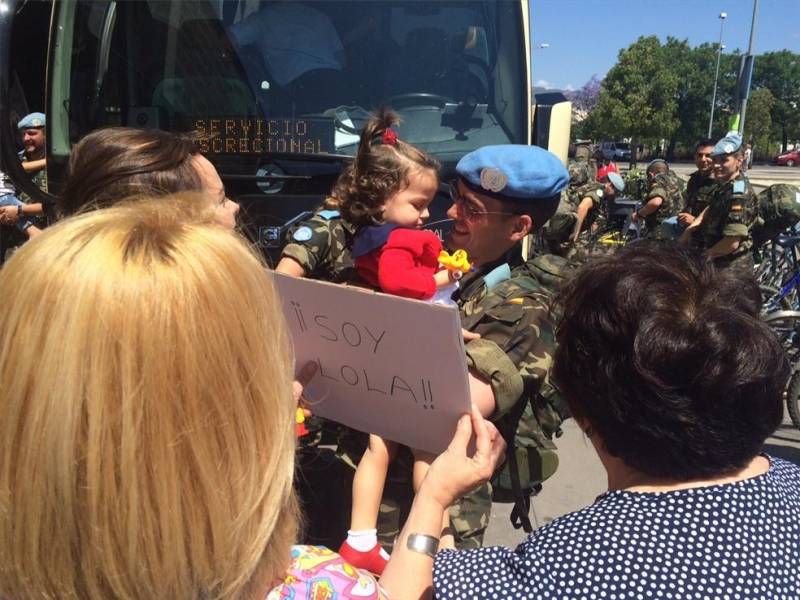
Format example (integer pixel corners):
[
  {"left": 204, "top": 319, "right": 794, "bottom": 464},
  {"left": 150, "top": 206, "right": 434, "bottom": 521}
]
[{"left": 272, "top": 273, "right": 469, "bottom": 453}]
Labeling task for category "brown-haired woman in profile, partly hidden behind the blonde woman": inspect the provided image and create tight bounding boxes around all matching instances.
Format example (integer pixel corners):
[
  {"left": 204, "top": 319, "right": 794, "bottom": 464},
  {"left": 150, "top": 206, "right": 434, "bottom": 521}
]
[{"left": 59, "top": 127, "right": 239, "bottom": 229}]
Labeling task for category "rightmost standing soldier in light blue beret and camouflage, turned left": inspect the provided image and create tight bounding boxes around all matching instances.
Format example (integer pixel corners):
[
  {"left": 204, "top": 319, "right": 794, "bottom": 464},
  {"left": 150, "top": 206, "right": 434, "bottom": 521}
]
[{"left": 684, "top": 133, "right": 758, "bottom": 276}]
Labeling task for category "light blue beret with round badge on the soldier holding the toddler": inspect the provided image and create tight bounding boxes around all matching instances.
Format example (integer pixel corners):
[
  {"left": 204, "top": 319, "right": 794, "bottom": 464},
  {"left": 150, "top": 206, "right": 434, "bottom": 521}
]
[{"left": 456, "top": 144, "right": 569, "bottom": 200}]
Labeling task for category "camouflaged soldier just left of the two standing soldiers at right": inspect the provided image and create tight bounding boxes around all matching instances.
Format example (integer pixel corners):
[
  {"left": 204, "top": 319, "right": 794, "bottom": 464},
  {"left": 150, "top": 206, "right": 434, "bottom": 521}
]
[{"left": 632, "top": 158, "right": 685, "bottom": 240}]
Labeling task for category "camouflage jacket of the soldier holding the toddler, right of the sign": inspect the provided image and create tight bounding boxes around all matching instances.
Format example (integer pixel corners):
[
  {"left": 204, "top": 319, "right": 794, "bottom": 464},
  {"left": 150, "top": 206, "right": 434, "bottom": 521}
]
[{"left": 454, "top": 247, "right": 566, "bottom": 445}]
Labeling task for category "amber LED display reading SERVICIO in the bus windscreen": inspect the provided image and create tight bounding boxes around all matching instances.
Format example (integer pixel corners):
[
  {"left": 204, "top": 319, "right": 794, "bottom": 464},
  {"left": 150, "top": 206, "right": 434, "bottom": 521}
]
[{"left": 194, "top": 118, "right": 335, "bottom": 154}]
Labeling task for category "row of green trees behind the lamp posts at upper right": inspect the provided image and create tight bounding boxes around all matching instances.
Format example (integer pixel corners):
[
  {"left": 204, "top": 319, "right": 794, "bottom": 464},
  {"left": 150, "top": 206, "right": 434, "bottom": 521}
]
[{"left": 580, "top": 36, "right": 800, "bottom": 156}]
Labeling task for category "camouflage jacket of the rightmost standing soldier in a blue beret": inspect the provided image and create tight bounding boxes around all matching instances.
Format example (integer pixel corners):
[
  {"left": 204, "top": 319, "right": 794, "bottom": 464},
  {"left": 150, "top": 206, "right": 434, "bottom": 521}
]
[{"left": 700, "top": 173, "right": 758, "bottom": 258}]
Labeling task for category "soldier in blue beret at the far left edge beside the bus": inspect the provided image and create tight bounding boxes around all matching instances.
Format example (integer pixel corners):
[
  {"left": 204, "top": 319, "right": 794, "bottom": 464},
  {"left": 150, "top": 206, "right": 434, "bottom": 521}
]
[{"left": 0, "top": 113, "right": 53, "bottom": 233}]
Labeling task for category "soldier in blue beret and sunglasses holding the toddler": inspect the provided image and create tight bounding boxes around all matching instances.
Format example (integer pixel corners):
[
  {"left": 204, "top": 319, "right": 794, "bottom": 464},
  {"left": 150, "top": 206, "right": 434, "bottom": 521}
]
[{"left": 279, "top": 146, "right": 568, "bottom": 548}]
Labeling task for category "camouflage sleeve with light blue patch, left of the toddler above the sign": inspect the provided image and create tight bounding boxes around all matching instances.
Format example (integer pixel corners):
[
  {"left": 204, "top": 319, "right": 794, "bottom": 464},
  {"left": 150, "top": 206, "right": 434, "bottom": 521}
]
[{"left": 281, "top": 210, "right": 358, "bottom": 283}]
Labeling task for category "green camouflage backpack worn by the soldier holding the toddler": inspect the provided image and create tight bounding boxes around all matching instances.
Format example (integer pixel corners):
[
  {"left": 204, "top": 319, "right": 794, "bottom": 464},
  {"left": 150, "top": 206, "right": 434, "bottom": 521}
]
[{"left": 492, "top": 254, "right": 571, "bottom": 533}]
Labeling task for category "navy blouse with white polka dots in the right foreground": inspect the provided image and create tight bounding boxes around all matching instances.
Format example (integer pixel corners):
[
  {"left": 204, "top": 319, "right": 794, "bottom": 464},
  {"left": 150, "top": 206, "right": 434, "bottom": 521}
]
[{"left": 433, "top": 458, "right": 800, "bottom": 600}]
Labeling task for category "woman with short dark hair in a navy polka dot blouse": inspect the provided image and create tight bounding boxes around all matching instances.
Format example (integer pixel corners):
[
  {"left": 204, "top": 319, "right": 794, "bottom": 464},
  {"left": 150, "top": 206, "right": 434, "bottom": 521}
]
[{"left": 386, "top": 245, "right": 800, "bottom": 600}]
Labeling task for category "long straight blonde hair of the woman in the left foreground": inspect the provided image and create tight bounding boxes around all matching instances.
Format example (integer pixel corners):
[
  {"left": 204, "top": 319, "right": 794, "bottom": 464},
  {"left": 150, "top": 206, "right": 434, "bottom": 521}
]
[{"left": 0, "top": 195, "right": 297, "bottom": 600}]
